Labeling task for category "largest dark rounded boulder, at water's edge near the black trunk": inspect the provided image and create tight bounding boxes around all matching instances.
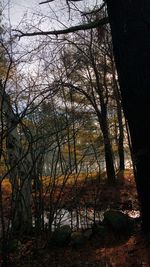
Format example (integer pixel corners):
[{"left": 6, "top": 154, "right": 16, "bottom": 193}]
[{"left": 103, "top": 210, "right": 133, "bottom": 234}]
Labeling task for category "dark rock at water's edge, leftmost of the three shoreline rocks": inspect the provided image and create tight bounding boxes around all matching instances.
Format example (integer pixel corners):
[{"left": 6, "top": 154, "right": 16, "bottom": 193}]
[{"left": 50, "top": 225, "right": 71, "bottom": 246}]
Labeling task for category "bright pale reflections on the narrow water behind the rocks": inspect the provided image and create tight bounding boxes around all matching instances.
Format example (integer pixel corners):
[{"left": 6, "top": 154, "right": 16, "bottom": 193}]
[{"left": 39, "top": 208, "right": 140, "bottom": 229}]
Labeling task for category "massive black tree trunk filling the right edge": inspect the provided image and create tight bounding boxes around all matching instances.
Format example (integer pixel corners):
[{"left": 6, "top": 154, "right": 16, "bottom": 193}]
[{"left": 107, "top": 0, "right": 150, "bottom": 232}]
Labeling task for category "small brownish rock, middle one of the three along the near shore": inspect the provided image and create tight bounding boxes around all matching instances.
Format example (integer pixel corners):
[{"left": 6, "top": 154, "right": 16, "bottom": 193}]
[{"left": 71, "top": 231, "right": 87, "bottom": 248}]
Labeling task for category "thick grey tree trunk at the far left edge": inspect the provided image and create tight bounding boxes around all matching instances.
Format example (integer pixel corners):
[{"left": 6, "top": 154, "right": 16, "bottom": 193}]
[{"left": 0, "top": 84, "right": 32, "bottom": 232}]
